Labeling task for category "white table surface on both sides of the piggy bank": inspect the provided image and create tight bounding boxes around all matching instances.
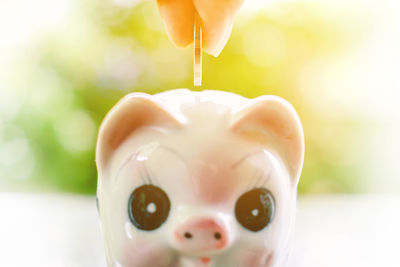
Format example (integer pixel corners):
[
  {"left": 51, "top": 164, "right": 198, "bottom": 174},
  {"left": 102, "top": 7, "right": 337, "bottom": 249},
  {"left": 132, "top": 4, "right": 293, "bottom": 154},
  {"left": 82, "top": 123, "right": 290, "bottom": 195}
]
[{"left": 0, "top": 193, "right": 400, "bottom": 267}]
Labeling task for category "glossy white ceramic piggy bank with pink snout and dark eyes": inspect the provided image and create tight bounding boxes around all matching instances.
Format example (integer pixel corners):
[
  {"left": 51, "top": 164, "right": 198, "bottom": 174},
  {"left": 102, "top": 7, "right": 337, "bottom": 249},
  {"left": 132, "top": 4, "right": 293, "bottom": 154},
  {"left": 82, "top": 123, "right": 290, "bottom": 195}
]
[{"left": 96, "top": 90, "right": 304, "bottom": 267}]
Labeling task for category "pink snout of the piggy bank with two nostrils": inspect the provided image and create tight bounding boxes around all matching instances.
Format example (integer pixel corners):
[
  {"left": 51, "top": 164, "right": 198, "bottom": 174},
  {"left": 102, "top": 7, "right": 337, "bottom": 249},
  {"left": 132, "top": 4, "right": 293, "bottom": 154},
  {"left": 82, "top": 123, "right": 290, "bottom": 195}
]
[{"left": 174, "top": 219, "right": 229, "bottom": 253}]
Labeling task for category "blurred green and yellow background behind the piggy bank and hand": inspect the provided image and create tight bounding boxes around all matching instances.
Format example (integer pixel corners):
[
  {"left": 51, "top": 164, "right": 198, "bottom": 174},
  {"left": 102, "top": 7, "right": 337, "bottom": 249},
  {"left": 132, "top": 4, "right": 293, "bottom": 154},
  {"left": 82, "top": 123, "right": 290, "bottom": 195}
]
[{"left": 0, "top": 0, "right": 400, "bottom": 194}]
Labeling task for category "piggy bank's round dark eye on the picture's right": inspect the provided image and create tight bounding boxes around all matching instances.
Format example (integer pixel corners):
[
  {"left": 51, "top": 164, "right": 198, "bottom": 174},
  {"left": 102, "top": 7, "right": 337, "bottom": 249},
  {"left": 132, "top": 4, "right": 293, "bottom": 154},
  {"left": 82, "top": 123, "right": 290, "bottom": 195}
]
[{"left": 235, "top": 188, "right": 275, "bottom": 232}]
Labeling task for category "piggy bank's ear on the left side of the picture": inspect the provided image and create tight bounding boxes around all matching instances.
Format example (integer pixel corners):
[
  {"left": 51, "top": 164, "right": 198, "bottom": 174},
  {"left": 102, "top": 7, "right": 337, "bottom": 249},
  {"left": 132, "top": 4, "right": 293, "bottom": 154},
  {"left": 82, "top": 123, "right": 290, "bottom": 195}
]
[{"left": 96, "top": 93, "right": 181, "bottom": 169}]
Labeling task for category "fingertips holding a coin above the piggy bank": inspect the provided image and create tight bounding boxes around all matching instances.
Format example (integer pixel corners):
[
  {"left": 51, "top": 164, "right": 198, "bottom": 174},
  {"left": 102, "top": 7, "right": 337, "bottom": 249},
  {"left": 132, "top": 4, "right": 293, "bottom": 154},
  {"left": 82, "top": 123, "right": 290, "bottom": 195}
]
[{"left": 157, "top": 0, "right": 244, "bottom": 56}]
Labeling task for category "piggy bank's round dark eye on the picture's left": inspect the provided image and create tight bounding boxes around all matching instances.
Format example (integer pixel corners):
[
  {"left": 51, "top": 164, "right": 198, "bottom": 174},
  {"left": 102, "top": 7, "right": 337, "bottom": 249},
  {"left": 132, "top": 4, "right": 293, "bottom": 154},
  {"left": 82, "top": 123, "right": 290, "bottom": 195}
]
[{"left": 128, "top": 185, "right": 171, "bottom": 231}]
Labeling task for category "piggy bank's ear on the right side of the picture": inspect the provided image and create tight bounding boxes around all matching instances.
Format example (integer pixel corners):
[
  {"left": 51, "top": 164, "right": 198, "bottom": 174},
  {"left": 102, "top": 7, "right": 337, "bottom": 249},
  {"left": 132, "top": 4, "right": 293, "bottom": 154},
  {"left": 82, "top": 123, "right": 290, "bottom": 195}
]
[{"left": 231, "top": 96, "right": 304, "bottom": 185}]
